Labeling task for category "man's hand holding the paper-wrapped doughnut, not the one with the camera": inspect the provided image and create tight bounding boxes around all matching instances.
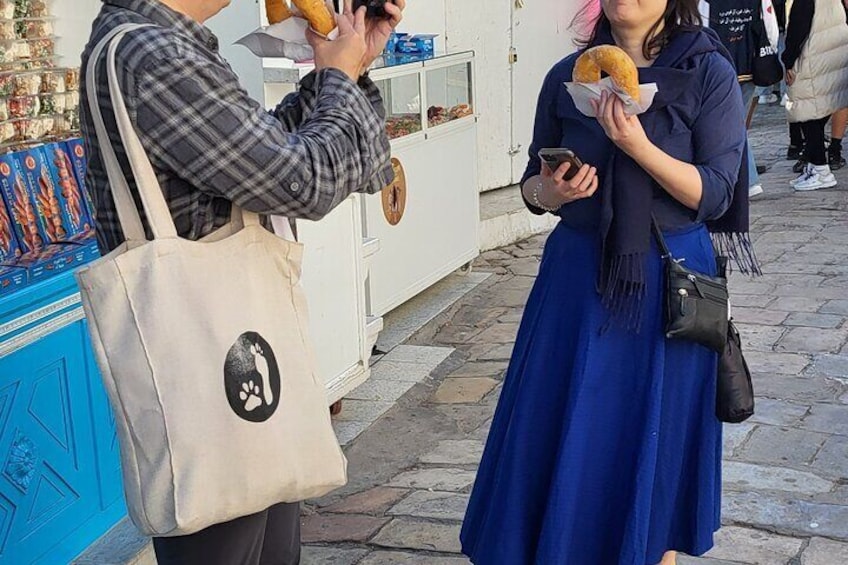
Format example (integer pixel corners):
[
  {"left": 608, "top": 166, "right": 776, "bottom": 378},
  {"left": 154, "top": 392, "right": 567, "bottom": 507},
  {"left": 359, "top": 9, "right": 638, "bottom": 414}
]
[{"left": 306, "top": 6, "right": 366, "bottom": 82}]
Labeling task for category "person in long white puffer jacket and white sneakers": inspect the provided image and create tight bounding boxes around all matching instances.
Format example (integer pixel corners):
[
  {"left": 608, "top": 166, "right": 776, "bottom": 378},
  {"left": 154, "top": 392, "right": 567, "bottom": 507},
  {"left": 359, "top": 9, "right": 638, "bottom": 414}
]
[{"left": 783, "top": 0, "right": 848, "bottom": 191}]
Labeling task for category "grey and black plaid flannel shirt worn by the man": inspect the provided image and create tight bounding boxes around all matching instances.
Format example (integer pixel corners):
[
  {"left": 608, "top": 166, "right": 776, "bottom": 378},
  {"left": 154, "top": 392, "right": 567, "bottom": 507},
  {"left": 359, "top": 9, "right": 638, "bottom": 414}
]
[{"left": 81, "top": 0, "right": 393, "bottom": 250}]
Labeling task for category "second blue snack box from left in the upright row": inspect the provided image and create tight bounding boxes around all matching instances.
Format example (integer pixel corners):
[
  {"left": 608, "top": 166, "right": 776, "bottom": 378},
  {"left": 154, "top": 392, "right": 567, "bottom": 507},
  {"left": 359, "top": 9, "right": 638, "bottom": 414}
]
[{"left": 0, "top": 153, "right": 44, "bottom": 255}]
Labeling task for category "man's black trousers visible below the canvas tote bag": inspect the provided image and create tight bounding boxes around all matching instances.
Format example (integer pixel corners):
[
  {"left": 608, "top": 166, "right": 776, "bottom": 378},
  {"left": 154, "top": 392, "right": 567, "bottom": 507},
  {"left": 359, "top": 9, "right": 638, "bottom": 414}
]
[{"left": 153, "top": 502, "right": 300, "bottom": 565}]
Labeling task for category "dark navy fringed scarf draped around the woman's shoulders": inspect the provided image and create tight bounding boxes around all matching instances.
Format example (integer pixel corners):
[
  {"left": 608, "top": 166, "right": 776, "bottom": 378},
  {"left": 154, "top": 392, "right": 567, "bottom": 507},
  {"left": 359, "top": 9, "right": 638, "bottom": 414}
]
[{"left": 595, "top": 25, "right": 761, "bottom": 331}]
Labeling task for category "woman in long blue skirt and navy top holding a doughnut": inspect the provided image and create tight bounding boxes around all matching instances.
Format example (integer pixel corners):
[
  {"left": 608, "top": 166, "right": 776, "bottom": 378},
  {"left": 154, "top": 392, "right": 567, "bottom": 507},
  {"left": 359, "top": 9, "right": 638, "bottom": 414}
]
[{"left": 461, "top": 0, "right": 754, "bottom": 565}]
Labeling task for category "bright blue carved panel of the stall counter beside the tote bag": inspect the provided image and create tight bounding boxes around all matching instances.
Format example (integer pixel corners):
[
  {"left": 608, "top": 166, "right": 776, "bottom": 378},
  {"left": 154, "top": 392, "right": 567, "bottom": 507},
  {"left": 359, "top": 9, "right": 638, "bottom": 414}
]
[{"left": 0, "top": 321, "right": 119, "bottom": 564}]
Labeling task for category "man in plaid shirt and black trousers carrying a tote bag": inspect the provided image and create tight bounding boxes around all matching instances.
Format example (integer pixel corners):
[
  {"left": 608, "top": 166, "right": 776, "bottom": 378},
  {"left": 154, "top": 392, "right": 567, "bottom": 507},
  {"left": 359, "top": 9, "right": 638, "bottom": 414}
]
[{"left": 81, "top": 0, "right": 405, "bottom": 565}]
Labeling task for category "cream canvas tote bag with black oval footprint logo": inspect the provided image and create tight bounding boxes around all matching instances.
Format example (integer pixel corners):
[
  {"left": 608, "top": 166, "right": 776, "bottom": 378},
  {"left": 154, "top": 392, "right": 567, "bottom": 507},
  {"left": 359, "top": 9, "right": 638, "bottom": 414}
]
[{"left": 77, "top": 25, "right": 347, "bottom": 536}]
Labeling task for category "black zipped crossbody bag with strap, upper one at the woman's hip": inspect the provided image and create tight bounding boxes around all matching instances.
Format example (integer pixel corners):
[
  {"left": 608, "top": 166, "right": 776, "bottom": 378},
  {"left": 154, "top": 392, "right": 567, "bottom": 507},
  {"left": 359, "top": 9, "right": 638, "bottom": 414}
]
[{"left": 651, "top": 218, "right": 729, "bottom": 353}]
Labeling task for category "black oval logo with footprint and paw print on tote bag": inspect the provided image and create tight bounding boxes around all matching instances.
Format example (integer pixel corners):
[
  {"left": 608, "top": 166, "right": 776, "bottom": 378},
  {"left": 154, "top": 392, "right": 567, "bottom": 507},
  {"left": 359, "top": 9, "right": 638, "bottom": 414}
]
[{"left": 224, "top": 332, "right": 282, "bottom": 422}]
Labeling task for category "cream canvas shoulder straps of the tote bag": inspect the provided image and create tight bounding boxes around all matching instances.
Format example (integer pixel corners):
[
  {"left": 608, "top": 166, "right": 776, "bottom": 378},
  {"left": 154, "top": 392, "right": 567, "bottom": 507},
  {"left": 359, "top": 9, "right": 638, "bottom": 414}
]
[{"left": 86, "top": 24, "right": 260, "bottom": 241}]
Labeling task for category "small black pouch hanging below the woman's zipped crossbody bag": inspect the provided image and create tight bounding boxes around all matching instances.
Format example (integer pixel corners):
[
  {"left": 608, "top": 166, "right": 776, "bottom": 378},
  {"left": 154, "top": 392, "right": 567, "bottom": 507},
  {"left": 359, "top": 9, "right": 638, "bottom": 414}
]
[{"left": 716, "top": 322, "right": 754, "bottom": 424}]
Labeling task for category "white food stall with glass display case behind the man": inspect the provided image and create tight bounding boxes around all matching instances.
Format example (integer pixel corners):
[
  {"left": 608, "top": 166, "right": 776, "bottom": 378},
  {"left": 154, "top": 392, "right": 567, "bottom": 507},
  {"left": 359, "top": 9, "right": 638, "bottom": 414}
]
[{"left": 209, "top": 6, "right": 479, "bottom": 403}]
